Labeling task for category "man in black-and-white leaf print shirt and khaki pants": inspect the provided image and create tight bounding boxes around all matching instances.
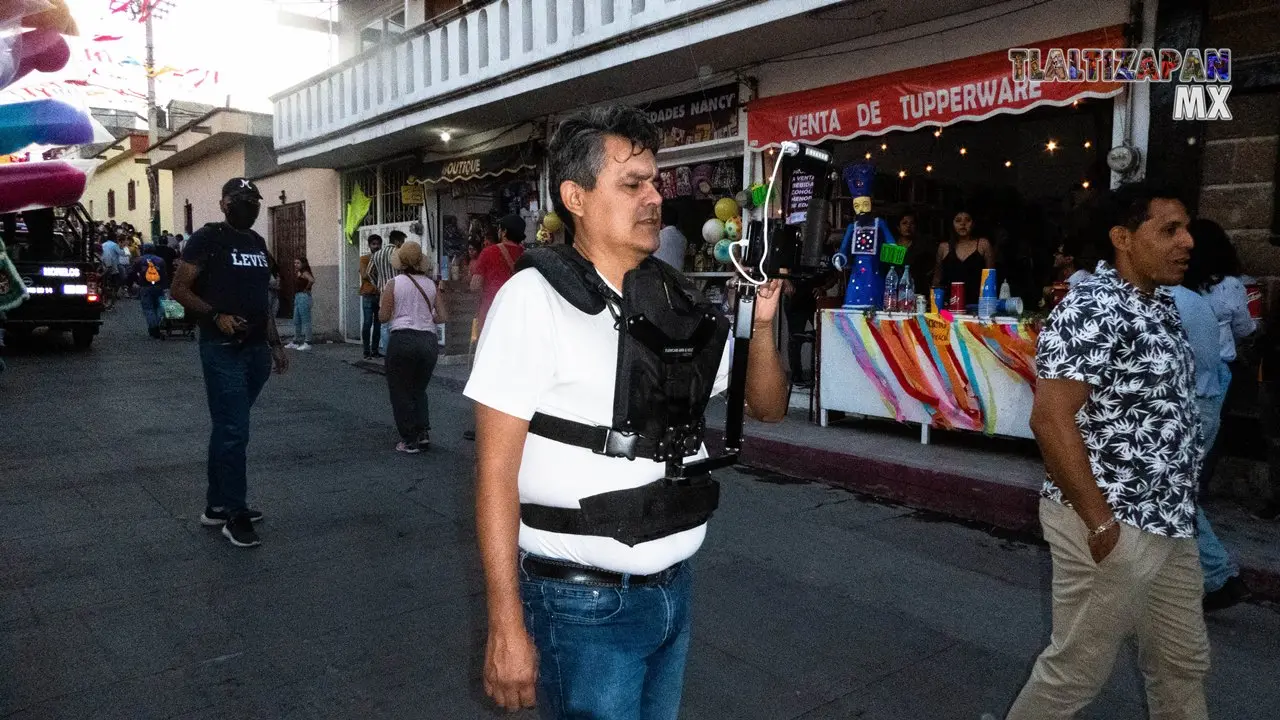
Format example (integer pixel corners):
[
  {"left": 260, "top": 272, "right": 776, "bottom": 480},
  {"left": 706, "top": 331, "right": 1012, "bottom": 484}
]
[{"left": 1009, "top": 184, "right": 1208, "bottom": 720}]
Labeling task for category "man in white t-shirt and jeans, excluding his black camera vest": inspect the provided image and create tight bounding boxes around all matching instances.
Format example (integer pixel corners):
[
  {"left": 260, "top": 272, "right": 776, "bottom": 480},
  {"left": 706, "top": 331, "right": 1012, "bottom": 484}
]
[{"left": 465, "top": 108, "right": 787, "bottom": 720}]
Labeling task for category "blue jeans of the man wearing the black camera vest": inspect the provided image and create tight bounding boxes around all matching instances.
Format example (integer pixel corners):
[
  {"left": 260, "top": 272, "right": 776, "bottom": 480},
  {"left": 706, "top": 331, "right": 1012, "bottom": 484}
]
[{"left": 520, "top": 552, "right": 692, "bottom": 720}]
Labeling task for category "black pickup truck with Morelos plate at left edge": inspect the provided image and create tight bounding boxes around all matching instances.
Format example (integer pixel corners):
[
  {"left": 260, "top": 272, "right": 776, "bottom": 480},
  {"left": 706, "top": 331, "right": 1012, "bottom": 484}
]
[{"left": 0, "top": 204, "right": 102, "bottom": 350}]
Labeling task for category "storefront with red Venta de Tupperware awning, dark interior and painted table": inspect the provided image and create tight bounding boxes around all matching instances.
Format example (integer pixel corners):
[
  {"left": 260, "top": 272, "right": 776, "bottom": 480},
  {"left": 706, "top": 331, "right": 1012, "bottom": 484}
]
[{"left": 748, "top": 27, "right": 1125, "bottom": 439}]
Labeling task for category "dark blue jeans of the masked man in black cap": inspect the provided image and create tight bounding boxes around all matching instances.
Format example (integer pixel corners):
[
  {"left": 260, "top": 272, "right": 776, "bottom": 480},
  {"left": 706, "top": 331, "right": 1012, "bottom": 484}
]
[{"left": 200, "top": 342, "right": 271, "bottom": 512}]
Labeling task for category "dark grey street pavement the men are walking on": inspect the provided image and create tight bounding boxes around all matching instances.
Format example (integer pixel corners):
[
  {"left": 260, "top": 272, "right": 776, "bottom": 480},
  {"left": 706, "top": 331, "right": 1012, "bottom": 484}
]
[{"left": 0, "top": 310, "right": 1280, "bottom": 720}]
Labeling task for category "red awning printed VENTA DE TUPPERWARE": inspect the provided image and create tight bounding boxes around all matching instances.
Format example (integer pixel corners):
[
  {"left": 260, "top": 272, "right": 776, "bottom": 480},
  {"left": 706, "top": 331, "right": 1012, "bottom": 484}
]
[{"left": 746, "top": 26, "right": 1125, "bottom": 147}]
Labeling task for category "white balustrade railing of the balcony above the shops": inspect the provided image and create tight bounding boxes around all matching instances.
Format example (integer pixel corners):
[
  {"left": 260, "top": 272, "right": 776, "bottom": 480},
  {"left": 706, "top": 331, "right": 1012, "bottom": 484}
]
[{"left": 273, "top": 0, "right": 742, "bottom": 151}]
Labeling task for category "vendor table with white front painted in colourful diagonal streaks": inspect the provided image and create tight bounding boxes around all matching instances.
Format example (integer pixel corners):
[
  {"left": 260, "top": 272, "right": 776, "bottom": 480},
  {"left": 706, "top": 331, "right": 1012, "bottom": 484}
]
[{"left": 818, "top": 309, "right": 1036, "bottom": 443}]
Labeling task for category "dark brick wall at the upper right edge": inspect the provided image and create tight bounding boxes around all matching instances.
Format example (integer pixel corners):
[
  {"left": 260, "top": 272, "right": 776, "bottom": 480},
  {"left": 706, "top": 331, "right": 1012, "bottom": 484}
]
[{"left": 1199, "top": 0, "right": 1280, "bottom": 275}]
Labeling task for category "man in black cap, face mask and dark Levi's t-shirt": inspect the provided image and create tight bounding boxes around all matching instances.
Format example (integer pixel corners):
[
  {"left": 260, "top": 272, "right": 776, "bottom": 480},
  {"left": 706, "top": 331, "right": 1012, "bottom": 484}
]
[{"left": 173, "top": 178, "right": 289, "bottom": 547}]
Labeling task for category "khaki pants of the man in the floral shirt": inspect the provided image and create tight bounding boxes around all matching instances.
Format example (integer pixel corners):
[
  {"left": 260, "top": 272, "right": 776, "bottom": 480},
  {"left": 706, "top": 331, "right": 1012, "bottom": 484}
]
[{"left": 1009, "top": 500, "right": 1208, "bottom": 720}]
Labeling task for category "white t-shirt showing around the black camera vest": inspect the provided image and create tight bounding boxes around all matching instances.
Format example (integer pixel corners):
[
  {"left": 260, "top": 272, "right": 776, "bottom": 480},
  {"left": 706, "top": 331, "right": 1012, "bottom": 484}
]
[{"left": 463, "top": 270, "right": 731, "bottom": 575}]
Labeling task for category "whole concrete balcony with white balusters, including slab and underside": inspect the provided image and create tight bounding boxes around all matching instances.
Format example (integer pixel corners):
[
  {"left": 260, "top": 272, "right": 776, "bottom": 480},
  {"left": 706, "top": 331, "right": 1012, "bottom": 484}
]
[{"left": 273, "top": 0, "right": 870, "bottom": 167}]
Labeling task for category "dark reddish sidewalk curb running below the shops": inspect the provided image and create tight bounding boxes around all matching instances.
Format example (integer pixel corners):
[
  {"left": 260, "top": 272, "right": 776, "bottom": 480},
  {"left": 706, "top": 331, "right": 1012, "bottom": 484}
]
[{"left": 351, "top": 360, "right": 1280, "bottom": 602}]
